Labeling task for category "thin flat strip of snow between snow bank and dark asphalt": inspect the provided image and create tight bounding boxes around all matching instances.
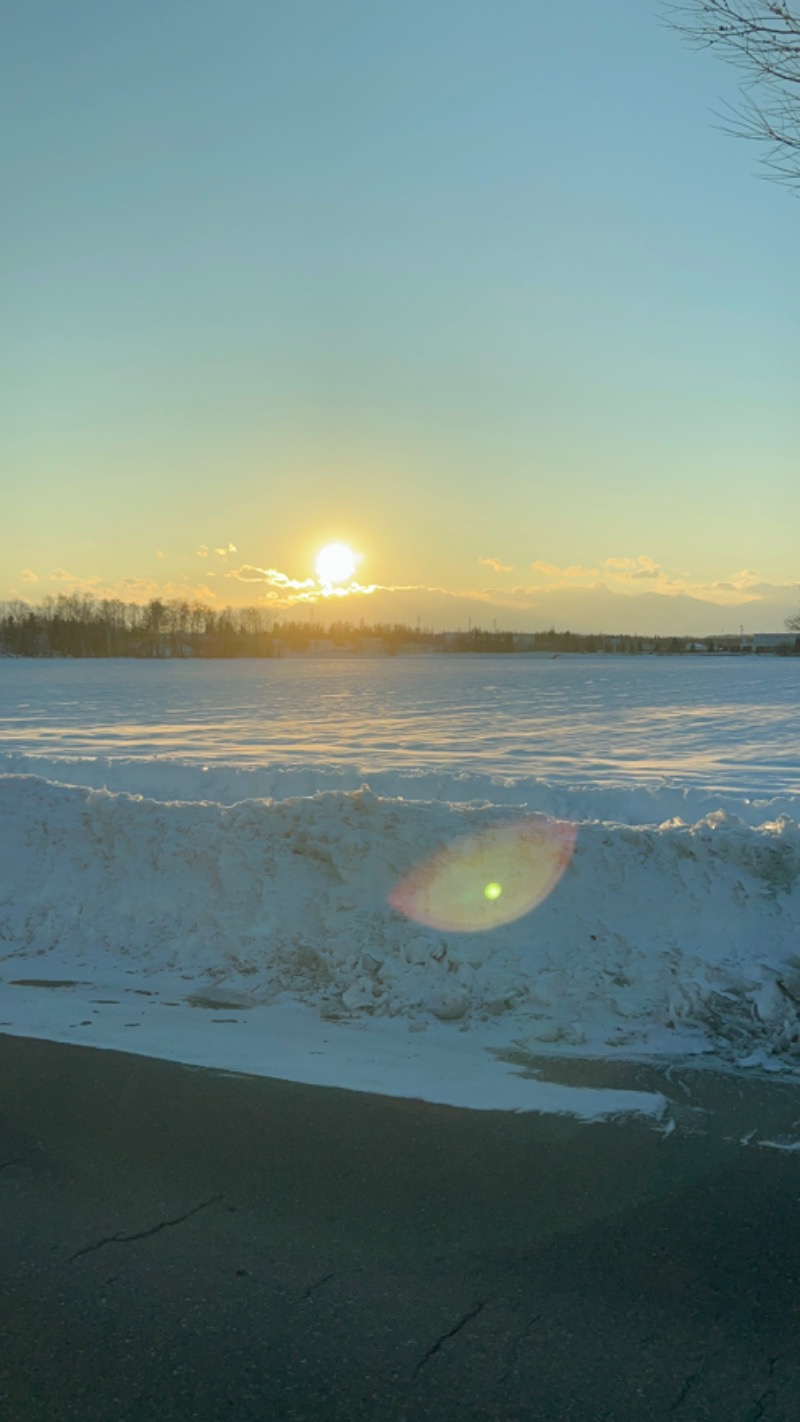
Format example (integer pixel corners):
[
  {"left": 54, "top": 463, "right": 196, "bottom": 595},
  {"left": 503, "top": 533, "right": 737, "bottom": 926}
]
[{"left": 0, "top": 974, "right": 668, "bottom": 1122}]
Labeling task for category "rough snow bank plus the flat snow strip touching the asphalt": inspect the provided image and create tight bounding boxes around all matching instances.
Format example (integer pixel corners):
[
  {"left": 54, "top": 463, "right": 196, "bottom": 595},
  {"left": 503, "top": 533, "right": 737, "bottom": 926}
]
[{"left": 0, "top": 659, "right": 800, "bottom": 1116}]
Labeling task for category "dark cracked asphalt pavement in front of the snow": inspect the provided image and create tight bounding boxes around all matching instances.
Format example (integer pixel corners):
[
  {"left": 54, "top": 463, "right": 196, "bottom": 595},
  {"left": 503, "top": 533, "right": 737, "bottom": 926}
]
[{"left": 0, "top": 1035, "right": 800, "bottom": 1422}]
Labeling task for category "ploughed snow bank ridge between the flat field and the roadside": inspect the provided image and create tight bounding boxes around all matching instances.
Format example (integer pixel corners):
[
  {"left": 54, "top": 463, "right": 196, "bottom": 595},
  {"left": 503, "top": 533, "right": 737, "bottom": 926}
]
[{"left": 0, "top": 757, "right": 800, "bottom": 1069}]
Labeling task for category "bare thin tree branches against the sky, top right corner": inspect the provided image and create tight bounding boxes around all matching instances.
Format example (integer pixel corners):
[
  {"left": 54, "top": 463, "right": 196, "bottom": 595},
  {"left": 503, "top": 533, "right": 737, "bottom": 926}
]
[{"left": 661, "top": 0, "right": 800, "bottom": 192}]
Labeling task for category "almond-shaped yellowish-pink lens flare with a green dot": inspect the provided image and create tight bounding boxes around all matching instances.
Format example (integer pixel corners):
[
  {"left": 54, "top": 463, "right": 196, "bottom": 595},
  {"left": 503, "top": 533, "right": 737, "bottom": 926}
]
[{"left": 389, "top": 815, "right": 575, "bottom": 933}]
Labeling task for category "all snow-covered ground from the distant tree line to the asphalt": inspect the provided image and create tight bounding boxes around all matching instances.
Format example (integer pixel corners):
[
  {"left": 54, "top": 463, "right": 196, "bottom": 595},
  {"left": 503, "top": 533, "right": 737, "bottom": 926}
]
[{"left": 0, "top": 657, "right": 800, "bottom": 1116}]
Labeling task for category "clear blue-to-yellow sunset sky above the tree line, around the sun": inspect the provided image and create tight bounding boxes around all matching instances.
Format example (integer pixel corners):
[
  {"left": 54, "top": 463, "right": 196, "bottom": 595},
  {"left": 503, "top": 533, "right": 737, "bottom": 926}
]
[{"left": 0, "top": 0, "right": 800, "bottom": 634}]
